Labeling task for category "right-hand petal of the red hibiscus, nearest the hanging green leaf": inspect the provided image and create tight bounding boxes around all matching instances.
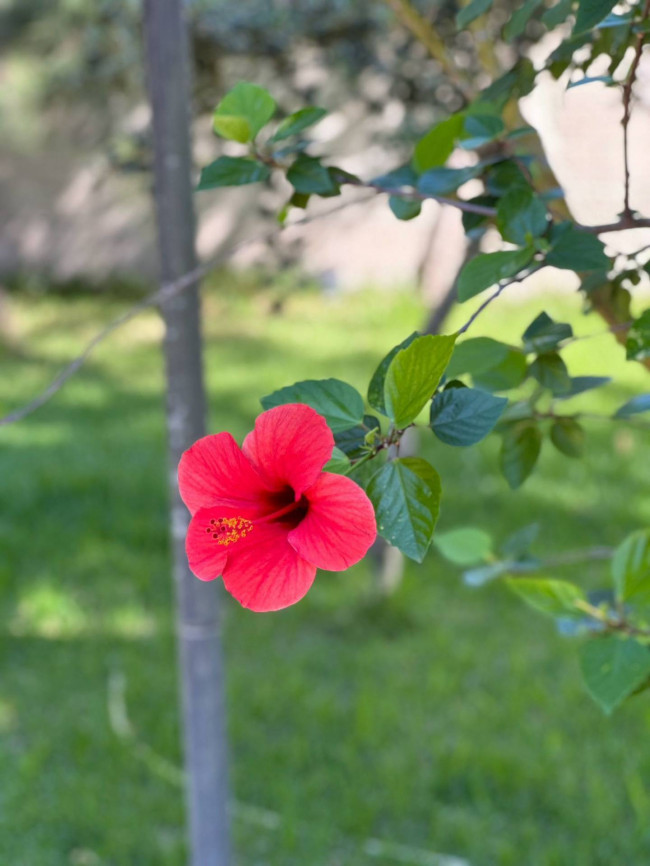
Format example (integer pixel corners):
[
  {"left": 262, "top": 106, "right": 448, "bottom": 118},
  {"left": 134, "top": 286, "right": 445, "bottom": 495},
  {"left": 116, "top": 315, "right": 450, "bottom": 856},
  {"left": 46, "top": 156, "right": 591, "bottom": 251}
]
[{"left": 289, "top": 472, "right": 377, "bottom": 571}]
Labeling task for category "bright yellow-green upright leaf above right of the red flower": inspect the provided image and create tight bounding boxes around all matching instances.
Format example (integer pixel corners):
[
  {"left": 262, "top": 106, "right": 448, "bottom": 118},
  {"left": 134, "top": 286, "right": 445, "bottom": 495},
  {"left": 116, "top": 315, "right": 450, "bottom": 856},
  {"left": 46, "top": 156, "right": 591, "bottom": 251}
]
[{"left": 384, "top": 334, "right": 456, "bottom": 429}]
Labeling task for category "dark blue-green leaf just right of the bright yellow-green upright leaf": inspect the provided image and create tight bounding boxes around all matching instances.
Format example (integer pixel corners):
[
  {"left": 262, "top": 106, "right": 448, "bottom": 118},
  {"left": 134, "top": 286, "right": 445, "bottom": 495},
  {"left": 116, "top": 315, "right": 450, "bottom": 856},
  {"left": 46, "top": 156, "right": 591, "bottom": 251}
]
[{"left": 430, "top": 388, "right": 508, "bottom": 445}]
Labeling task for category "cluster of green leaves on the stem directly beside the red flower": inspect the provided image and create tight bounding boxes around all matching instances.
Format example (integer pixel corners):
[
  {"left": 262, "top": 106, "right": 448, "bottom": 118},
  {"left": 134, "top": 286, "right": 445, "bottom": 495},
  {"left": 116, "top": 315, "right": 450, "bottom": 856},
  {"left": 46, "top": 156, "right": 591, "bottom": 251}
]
[{"left": 262, "top": 333, "right": 470, "bottom": 562}]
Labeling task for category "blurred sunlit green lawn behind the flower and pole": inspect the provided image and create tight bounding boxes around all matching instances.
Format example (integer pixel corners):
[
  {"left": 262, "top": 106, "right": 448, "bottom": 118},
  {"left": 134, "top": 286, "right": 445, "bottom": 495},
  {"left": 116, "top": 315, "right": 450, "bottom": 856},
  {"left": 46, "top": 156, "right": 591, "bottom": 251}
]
[{"left": 0, "top": 275, "right": 650, "bottom": 866}]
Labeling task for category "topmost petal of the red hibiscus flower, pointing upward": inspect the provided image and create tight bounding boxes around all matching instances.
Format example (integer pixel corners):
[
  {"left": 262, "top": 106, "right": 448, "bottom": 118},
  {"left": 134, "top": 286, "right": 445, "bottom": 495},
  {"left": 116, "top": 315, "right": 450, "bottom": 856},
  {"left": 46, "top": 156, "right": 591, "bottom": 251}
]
[{"left": 242, "top": 403, "right": 334, "bottom": 501}]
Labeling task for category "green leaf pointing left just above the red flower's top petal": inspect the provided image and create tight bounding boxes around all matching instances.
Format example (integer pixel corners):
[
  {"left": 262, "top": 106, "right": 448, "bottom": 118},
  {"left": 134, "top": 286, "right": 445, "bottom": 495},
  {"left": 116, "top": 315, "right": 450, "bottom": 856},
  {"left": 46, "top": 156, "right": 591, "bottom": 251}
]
[{"left": 260, "top": 379, "right": 363, "bottom": 432}]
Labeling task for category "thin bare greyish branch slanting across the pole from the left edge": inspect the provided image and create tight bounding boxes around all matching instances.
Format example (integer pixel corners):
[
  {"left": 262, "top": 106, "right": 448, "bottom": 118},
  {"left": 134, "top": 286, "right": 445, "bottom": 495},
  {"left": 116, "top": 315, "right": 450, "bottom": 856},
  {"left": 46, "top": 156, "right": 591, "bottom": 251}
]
[{"left": 0, "top": 199, "right": 370, "bottom": 427}]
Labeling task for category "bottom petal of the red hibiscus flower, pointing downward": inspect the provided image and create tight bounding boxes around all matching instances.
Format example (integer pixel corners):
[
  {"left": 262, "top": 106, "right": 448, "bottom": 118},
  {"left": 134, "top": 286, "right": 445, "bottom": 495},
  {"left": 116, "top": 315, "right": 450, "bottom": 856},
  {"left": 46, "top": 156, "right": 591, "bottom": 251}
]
[{"left": 223, "top": 523, "right": 316, "bottom": 611}]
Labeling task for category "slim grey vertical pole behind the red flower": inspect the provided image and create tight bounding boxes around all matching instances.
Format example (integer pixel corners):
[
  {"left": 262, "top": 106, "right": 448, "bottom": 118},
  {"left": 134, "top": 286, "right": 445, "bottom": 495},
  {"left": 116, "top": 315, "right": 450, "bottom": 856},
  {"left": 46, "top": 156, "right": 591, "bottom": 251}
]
[{"left": 144, "top": 0, "right": 230, "bottom": 866}]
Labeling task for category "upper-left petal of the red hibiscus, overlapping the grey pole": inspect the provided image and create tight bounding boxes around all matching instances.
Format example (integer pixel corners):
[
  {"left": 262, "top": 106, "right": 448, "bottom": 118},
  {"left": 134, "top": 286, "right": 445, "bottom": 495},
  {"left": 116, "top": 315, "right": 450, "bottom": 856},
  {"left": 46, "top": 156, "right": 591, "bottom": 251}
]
[{"left": 178, "top": 433, "right": 268, "bottom": 514}]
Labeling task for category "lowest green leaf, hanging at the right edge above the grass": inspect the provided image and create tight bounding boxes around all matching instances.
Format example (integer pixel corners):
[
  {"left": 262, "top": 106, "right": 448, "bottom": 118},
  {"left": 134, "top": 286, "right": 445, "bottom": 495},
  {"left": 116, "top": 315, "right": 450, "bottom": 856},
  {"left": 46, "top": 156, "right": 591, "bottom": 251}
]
[{"left": 580, "top": 635, "right": 650, "bottom": 715}]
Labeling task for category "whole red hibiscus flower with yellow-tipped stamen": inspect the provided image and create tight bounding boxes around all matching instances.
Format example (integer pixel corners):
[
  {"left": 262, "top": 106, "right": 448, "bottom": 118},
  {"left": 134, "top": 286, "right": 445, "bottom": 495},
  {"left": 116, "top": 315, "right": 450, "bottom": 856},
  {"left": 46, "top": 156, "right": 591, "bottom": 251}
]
[{"left": 178, "top": 403, "right": 377, "bottom": 611}]
